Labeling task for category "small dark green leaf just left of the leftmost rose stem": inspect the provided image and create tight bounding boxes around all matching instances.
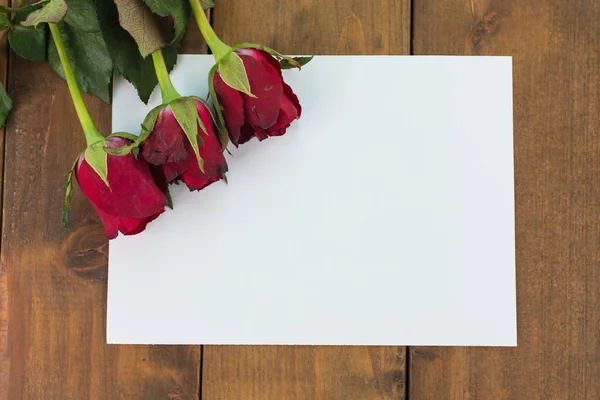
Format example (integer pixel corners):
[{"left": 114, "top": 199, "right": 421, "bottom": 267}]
[{"left": 8, "top": 10, "right": 48, "bottom": 61}]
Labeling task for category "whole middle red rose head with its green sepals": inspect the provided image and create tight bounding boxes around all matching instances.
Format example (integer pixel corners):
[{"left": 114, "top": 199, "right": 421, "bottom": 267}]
[{"left": 140, "top": 97, "right": 227, "bottom": 190}]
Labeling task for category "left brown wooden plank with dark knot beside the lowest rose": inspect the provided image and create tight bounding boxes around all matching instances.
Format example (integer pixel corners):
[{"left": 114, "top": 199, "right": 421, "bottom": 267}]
[{"left": 0, "top": 16, "right": 200, "bottom": 400}]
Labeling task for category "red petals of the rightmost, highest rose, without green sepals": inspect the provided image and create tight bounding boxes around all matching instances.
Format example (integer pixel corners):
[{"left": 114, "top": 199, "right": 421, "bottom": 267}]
[{"left": 213, "top": 49, "right": 302, "bottom": 146}]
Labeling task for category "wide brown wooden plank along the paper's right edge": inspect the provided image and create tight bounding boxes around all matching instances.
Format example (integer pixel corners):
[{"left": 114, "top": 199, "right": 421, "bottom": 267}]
[{"left": 409, "top": 0, "right": 600, "bottom": 400}]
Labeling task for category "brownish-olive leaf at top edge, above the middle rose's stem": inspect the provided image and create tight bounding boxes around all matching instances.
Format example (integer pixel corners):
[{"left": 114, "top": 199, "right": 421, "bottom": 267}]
[{"left": 113, "top": 0, "right": 169, "bottom": 58}]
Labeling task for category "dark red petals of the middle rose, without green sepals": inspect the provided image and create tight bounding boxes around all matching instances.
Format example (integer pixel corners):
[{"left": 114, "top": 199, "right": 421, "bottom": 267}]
[{"left": 141, "top": 100, "right": 227, "bottom": 190}]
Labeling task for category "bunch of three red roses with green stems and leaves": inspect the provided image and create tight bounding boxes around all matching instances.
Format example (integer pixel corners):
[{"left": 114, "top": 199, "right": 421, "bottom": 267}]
[{"left": 0, "top": 0, "right": 311, "bottom": 239}]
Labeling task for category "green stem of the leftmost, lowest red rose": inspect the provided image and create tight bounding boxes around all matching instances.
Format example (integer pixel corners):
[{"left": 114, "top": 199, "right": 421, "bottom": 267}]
[{"left": 48, "top": 23, "right": 104, "bottom": 146}]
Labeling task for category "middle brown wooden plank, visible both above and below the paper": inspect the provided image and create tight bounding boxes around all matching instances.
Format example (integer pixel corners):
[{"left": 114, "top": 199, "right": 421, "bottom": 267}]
[{"left": 202, "top": 0, "right": 410, "bottom": 400}]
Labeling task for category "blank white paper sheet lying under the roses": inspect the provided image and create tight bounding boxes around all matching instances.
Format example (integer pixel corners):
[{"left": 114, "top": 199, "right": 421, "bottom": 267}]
[{"left": 107, "top": 55, "right": 517, "bottom": 346}]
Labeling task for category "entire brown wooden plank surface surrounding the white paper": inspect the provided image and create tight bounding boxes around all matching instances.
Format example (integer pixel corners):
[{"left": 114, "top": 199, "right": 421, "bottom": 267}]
[{"left": 0, "top": 0, "right": 600, "bottom": 400}]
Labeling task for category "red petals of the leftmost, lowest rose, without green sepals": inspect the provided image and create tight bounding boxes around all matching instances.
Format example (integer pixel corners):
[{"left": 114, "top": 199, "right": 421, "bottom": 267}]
[{"left": 75, "top": 137, "right": 167, "bottom": 239}]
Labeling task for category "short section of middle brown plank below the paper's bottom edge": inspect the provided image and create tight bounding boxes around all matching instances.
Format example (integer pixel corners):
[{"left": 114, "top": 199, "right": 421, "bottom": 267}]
[{"left": 202, "top": 346, "right": 406, "bottom": 400}]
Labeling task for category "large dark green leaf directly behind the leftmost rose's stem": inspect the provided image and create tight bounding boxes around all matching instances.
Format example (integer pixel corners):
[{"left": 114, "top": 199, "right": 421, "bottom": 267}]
[{"left": 48, "top": 23, "right": 113, "bottom": 103}]
